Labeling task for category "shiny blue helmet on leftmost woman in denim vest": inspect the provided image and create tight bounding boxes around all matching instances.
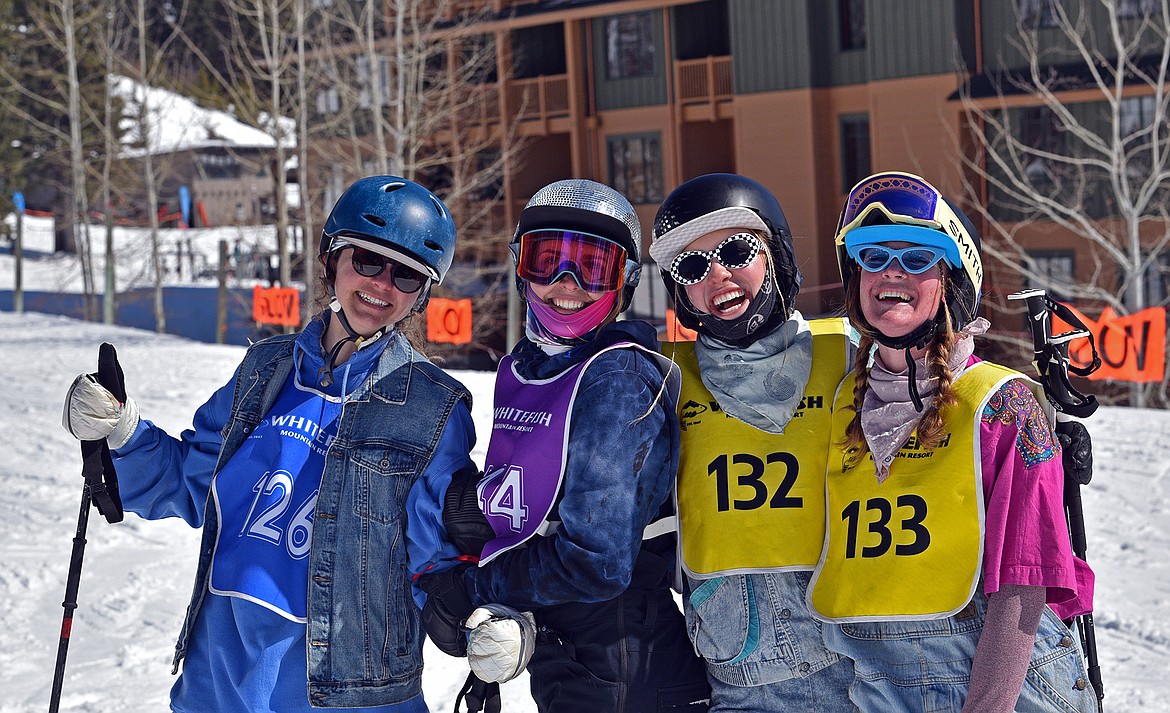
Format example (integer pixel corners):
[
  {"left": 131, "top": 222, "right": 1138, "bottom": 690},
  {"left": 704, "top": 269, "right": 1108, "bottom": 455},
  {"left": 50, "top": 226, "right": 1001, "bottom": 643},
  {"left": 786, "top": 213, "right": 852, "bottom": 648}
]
[{"left": 317, "top": 176, "right": 455, "bottom": 283}]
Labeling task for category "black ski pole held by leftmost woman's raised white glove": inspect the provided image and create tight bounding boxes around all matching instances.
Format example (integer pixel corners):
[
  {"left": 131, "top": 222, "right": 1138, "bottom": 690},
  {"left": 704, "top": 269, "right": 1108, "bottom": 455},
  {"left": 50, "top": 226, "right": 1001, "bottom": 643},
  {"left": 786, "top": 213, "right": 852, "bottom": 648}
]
[{"left": 49, "top": 343, "right": 126, "bottom": 713}]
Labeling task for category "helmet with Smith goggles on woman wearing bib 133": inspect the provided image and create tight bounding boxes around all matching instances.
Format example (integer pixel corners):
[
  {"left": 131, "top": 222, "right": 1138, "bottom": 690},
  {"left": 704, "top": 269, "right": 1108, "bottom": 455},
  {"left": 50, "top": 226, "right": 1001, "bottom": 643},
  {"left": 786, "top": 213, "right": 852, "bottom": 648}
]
[{"left": 835, "top": 171, "right": 983, "bottom": 349}]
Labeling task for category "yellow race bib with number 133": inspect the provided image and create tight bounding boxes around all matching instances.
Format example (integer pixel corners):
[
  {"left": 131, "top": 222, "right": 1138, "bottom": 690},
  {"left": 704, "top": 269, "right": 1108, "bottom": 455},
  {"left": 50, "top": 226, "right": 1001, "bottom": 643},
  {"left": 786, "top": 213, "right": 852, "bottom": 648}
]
[{"left": 808, "top": 362, "right": 1021, "bottom": 622}]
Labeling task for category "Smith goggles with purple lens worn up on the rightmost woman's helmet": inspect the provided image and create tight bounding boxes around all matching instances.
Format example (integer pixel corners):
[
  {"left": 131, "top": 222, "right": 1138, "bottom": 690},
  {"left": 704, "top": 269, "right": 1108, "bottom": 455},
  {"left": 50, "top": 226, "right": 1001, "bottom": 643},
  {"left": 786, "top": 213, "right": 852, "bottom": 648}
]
[{"left": 837, "top": 172, "right": 983, "bottom": 292}]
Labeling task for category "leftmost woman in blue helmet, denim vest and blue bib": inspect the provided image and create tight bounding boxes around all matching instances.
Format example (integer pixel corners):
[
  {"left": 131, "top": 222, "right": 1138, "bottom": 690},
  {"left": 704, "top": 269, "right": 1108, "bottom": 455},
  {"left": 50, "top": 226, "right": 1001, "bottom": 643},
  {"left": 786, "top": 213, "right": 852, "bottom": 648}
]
[{"left": 64, "top": 176, "right": 475, "bottom": 713}]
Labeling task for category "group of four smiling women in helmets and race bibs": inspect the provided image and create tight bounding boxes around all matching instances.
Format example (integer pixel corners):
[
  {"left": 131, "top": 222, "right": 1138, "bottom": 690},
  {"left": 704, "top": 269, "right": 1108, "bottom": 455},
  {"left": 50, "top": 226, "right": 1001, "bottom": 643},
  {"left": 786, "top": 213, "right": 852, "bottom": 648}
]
[{"left": 66, "top": 172, "right": 1096, "bottom": 713}]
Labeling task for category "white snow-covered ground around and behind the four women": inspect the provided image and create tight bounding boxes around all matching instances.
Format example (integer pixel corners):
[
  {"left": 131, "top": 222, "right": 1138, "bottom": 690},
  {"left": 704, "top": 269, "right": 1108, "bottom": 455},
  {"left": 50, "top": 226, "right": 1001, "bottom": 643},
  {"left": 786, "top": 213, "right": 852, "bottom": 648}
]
[{"left": 0, "top": 313, "right": 1170, "bottom": 713}]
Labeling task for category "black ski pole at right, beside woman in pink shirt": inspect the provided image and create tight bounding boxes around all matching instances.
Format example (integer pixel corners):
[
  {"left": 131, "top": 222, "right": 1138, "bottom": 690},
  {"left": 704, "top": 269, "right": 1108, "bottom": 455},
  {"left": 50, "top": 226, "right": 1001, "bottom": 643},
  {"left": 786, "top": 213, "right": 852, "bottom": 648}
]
[{"left": 1007, "top": 289, "right": 1104, "bottom": 713}]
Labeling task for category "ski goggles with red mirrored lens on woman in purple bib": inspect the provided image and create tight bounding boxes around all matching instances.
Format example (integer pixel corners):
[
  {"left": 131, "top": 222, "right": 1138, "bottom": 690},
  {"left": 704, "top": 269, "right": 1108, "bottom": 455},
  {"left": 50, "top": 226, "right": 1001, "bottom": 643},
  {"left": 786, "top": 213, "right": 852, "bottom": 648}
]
[{"left": 516, "top": 231, "right": 628, "bottom": 293}]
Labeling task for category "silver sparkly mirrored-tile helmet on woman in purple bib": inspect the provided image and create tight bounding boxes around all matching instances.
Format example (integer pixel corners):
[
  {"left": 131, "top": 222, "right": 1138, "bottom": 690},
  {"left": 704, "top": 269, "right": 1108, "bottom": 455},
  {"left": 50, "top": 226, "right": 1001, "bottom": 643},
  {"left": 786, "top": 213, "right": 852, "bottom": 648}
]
[{"left": 508, "top": 178, "right": 642, "bottom": 313}]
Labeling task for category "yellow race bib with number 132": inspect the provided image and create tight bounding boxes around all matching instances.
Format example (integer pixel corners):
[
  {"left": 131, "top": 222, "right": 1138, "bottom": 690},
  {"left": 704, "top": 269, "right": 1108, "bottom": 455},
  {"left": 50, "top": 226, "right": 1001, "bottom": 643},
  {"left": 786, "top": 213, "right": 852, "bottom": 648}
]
[{"left": 668, "top": 320, "right": 847, "bottom": 578}]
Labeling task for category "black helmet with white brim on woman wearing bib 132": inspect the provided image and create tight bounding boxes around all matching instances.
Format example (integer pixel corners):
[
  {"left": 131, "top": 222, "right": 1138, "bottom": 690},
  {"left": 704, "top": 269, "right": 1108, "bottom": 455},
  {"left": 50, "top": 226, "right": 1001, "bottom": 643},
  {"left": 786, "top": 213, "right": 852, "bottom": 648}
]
[{"left": 651, "top": 173, "right": 804, "bottom": 334}]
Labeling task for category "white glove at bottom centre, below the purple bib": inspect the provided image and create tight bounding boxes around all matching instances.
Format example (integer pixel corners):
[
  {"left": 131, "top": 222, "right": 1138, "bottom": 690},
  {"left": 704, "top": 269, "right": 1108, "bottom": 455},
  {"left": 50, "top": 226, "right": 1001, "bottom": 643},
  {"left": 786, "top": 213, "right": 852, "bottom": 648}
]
[{"left": 463, "top": 604, "right": 536, "bottom": 684}]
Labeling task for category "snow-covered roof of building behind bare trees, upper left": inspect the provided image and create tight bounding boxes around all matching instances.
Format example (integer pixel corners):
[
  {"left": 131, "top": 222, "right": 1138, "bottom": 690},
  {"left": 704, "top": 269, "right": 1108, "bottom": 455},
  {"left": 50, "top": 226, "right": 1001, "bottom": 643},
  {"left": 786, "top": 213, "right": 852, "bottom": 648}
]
[{"left": 110, "top": 76, "right": 296, "bottom": 157}]
